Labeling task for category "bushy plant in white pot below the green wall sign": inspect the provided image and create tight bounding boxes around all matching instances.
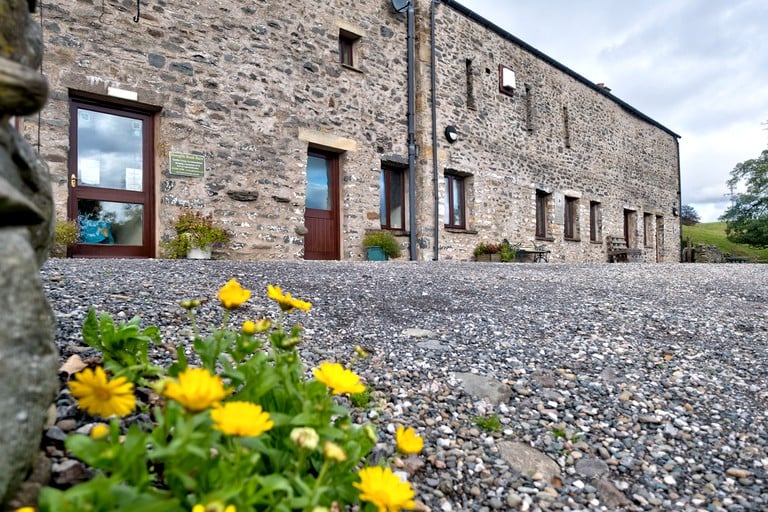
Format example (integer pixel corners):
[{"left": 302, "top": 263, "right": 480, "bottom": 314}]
[{"left": 163, "top": 210, "right": 232, "bottom": 259}]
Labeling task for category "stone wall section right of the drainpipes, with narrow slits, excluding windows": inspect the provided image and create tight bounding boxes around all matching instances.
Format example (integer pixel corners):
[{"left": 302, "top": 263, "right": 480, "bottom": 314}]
[{"left": 426, "top": 1, "right": 680, "bottom": 262}]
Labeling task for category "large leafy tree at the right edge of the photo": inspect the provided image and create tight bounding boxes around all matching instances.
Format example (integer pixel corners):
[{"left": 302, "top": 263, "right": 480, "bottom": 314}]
[{"left": 720, "top": 149, "right": 768, "bottom": 248}]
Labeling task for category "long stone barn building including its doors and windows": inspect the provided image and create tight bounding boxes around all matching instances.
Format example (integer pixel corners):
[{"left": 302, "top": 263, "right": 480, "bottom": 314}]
[{"left": 27, "top": 0, "right": 680, "bottom": 263}]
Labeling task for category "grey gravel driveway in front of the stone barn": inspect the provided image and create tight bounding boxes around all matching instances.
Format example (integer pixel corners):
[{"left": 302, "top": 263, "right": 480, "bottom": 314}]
[{"left": 42, "top": 259, "right": 768, "bottom": 511}]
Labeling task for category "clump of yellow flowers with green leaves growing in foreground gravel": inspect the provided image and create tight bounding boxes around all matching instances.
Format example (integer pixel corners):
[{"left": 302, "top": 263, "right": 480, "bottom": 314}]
[{"left": 39, "top": 279, "right": 424, "bottom": 512}]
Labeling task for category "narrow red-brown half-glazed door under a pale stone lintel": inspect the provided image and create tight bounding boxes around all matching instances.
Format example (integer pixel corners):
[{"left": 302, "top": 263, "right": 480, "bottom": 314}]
[{"left": 304, "top": 151, "right": 340, "bottom": 260}]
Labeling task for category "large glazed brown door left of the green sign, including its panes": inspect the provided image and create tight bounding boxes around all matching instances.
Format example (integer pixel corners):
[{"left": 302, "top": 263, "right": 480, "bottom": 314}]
[{"left": 68, "top": 100, "right": 155, "bottom": 258}]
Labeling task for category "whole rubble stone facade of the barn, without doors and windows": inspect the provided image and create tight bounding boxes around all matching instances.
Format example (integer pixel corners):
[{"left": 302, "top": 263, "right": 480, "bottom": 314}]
[{"left": 25, "top": 0, "right": 679, "bottom": 262}]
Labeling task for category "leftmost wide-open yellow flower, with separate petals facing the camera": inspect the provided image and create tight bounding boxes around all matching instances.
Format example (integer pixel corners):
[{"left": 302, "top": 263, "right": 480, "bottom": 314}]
[{"left": 69, "top": 367, "right": 136, "bottom": 418}]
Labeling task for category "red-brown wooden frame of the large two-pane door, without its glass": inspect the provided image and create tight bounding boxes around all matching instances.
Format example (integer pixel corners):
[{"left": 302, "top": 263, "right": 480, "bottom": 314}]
[{"left": 67, "top": 94, "right": 160, "bottom": 258}]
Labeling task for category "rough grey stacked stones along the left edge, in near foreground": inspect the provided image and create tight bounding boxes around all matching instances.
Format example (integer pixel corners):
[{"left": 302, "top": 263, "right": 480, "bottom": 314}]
[{"left": 0, "top": 0, "right": 58, "bottom": 505}]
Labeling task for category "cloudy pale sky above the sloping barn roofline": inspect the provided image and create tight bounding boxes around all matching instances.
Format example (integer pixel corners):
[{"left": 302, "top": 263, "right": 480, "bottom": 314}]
[{"left": 458, "top": 0, "right": 768, "bottom": 222}]
